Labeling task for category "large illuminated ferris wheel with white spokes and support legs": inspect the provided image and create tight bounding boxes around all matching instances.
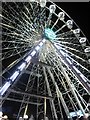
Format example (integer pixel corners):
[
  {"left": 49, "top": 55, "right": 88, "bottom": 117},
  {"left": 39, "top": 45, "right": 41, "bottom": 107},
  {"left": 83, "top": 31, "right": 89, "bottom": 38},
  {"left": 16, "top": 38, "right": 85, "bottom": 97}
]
[{"left": 0, "top": 0, "right": 90, "bottom": 120}]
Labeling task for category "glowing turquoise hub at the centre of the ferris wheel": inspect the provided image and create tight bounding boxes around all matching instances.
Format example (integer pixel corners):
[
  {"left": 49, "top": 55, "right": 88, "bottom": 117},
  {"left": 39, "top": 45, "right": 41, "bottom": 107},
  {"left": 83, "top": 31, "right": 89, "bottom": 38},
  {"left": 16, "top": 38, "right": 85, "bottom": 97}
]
[{"left": 44, "top": 28, "right": 56, "bottom": 40}]
